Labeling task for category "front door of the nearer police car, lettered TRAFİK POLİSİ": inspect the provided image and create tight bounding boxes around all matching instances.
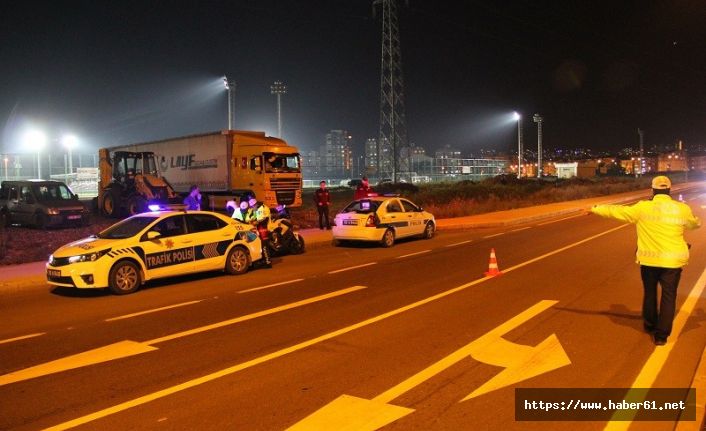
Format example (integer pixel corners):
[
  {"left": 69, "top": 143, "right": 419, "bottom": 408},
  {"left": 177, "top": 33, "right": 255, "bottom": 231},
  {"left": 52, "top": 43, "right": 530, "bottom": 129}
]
[{"left": 140, "top": 214, "right": 195, "bottom": 278}]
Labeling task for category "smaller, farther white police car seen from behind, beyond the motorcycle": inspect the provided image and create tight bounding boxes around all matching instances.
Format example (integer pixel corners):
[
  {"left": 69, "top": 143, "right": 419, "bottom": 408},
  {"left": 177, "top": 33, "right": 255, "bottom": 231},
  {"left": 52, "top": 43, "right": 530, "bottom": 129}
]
[{"left": 333, "top": 196, "right": 436, "bottom": 247}]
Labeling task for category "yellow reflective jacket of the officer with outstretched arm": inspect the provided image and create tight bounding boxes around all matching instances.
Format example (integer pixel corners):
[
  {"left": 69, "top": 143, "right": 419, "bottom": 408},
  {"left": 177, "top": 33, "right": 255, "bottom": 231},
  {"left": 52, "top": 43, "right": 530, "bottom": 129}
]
[{"left": 591, "top": 194, "right": 701, "bottom": 268}]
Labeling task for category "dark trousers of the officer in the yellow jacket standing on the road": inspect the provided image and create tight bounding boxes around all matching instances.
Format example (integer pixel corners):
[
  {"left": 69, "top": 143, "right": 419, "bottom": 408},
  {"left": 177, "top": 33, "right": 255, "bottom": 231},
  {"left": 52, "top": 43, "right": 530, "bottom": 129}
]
[{"left": 640, "top": 265, "right": 681, "bottom": 339}]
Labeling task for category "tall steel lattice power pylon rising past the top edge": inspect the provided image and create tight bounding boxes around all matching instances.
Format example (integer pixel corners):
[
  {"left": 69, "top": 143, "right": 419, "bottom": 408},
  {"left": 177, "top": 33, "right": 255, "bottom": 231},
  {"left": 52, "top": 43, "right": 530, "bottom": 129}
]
[{"left": 373, "top": 0, "right": 411, "bottom": 182}]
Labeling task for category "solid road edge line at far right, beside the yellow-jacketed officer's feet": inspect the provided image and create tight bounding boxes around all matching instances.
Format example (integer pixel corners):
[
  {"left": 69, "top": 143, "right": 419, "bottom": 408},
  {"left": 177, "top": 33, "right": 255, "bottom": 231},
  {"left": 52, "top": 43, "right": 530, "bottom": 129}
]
[{"left": 604, "top": 269, "right": 706, "bottom": 430}]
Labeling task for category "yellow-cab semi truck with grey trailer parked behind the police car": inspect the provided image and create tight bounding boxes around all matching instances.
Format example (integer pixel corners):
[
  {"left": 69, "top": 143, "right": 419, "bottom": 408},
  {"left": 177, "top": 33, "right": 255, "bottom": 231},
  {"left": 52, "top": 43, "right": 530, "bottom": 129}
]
[{"left": 106, "top": 130, "right": 302, "bottom": 210}]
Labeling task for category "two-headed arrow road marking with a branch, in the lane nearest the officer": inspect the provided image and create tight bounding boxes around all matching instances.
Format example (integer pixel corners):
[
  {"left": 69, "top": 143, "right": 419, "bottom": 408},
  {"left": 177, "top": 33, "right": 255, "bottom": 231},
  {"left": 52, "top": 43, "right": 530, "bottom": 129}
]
[{"left": 289, "top": 300, "right": 571, "bottom": 431}]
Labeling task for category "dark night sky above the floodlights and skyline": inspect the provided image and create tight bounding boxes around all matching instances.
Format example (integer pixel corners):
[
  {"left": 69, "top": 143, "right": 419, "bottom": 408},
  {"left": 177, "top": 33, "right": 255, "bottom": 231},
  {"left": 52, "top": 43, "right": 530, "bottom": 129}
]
[{"left": 0, "top": 0, "right": 706, "bottom": 154}]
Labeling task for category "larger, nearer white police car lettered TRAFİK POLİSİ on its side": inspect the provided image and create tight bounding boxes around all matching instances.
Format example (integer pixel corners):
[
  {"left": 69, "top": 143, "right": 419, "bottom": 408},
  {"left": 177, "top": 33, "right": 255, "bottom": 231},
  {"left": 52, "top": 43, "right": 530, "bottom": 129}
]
[{"left": 46, "top": 211, "right": 262, "bottom": 295}]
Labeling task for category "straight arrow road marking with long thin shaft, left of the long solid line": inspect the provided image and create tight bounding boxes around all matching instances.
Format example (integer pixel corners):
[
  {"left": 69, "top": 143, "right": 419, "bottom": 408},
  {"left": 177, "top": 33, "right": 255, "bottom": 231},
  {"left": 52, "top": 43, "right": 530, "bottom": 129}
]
[{"left": 0, "top": 286, "right": 366, "bottom": 386}]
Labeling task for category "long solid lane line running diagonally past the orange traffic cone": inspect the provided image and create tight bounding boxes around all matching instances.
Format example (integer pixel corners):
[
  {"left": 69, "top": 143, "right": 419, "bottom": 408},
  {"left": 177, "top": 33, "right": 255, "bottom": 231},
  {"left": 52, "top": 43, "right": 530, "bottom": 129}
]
[{"left": 44, "top": 224, "right": 631, "bottom": 431}]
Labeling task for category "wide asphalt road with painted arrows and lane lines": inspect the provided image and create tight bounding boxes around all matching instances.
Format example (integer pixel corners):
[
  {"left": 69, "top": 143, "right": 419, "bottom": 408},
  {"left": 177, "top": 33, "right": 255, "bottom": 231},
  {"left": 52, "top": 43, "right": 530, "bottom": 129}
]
[{"left": 0, "top": 190, "right": 706, "bottom": 430}]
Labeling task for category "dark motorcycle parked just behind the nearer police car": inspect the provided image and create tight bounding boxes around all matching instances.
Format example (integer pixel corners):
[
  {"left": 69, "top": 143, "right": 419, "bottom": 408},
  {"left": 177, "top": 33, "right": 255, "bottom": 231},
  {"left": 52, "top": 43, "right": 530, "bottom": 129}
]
[{"left": 256, "top": 206, "right": 305, "bottom": 256}]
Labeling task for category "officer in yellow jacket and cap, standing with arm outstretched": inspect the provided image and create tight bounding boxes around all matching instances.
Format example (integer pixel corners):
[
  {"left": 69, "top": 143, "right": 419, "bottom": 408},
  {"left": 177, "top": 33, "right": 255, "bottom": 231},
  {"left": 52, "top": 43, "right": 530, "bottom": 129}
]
[{"left": 591, "top": 176, "right": 701, "bottom": 346}]
